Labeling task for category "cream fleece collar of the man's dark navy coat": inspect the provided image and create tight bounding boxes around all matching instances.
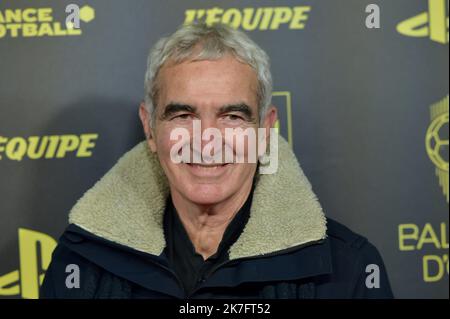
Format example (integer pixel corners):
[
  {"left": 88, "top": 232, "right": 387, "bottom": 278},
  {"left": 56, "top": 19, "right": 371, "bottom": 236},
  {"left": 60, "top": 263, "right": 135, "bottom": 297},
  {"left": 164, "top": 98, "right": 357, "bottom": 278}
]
[{"left": 69, "top": 136, "right": 326, "bottom": 259}]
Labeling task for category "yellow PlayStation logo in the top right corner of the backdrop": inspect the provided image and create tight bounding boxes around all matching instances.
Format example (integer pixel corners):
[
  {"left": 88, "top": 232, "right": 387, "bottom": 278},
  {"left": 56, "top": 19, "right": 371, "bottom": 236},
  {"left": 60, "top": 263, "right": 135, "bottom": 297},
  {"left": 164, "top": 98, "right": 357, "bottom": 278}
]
[{"left": 397, "top": 0, "right": 448, "bottom": 44}]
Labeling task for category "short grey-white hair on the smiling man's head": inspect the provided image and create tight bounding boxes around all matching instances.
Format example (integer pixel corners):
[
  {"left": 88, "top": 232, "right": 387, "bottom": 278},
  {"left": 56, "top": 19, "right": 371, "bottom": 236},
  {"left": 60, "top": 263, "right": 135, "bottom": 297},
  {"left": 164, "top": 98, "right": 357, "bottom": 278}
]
[{"left": 145, "top": 22, "right": 272, "bottom": 124}]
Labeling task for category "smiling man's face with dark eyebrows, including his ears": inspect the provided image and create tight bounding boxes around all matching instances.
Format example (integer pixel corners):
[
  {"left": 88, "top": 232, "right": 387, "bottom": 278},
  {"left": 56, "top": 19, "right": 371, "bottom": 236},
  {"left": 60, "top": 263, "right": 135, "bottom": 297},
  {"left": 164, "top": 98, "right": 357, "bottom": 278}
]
[{"left": 140, "top": 55, "right": 276, "bottom": 205}]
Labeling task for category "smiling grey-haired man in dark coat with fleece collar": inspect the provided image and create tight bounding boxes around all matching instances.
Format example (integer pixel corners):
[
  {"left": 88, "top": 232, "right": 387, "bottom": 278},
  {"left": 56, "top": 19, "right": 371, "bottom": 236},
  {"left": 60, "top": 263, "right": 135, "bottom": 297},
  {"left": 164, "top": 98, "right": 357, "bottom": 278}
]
[{"left": 41, "top": 23, "right": 392, "bottom": 299}]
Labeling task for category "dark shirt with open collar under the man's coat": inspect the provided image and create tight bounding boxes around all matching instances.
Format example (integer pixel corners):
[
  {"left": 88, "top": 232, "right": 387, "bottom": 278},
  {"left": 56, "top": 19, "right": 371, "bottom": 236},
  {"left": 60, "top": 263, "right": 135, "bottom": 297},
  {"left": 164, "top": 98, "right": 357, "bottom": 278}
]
[{"left": 164, "top": 188, "right": 253, "bottom": 295}]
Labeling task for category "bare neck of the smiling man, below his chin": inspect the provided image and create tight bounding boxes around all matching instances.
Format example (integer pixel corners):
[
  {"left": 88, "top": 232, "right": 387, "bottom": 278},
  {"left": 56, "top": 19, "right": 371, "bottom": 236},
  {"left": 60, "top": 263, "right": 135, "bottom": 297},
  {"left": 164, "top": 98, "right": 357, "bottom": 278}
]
[{"left": 171, "top": 183, "right": 252, "bottom": 260}]
